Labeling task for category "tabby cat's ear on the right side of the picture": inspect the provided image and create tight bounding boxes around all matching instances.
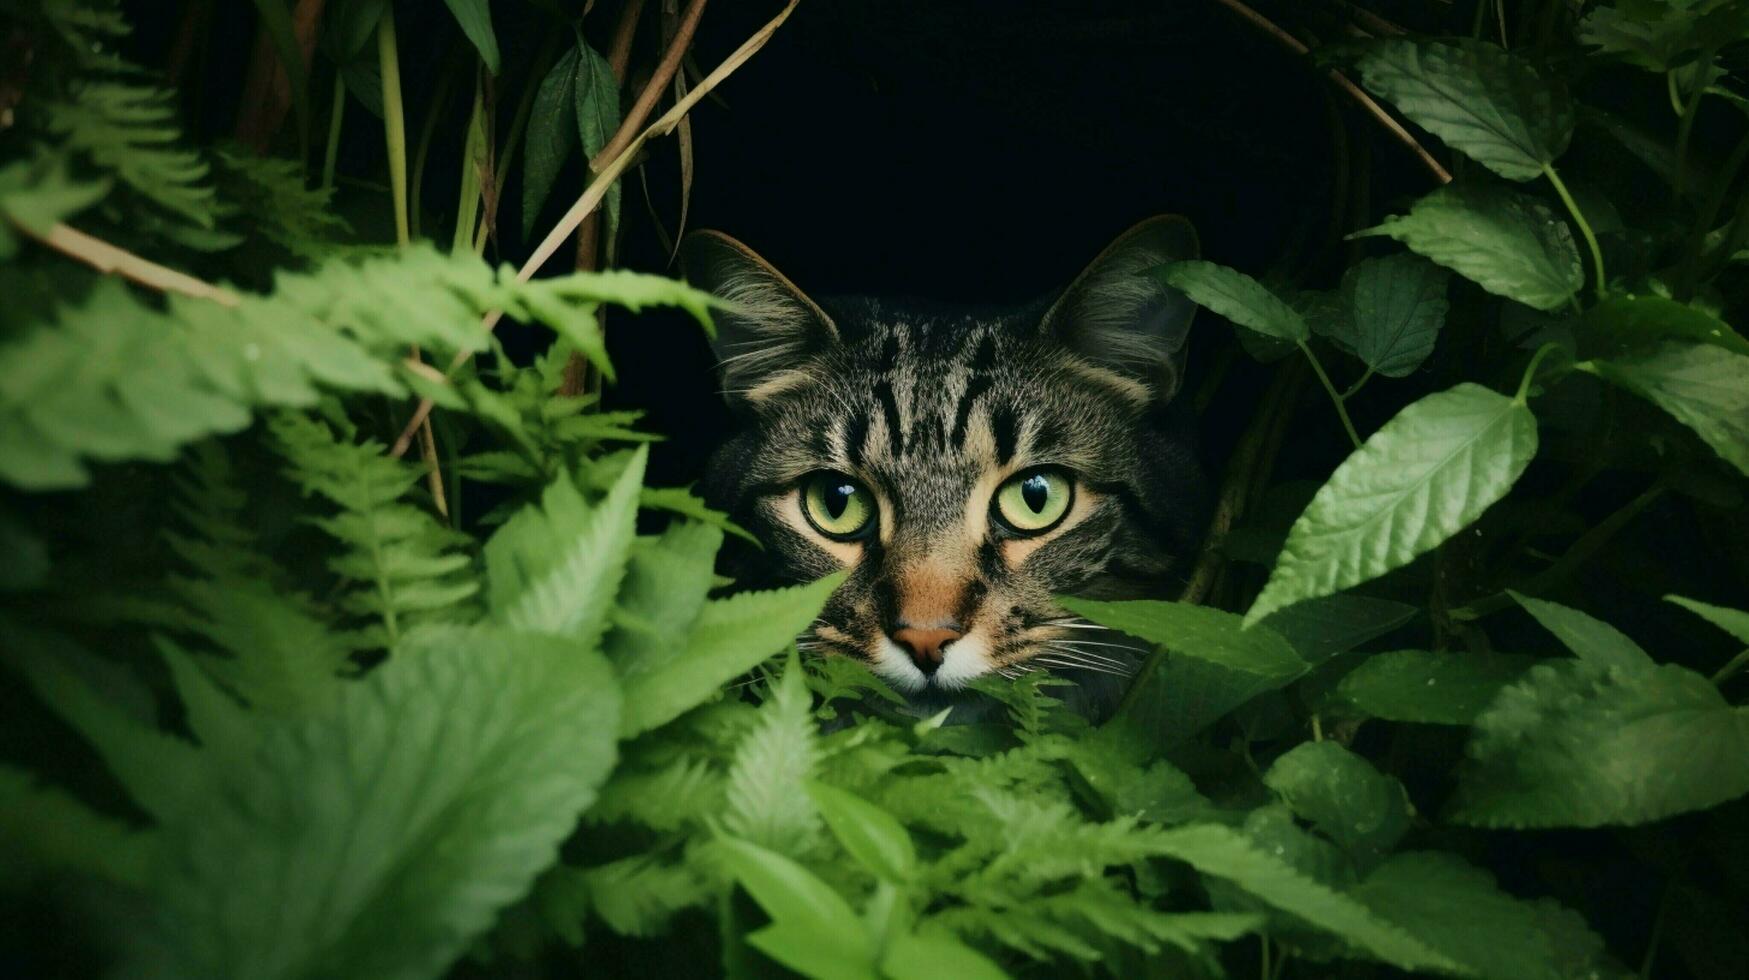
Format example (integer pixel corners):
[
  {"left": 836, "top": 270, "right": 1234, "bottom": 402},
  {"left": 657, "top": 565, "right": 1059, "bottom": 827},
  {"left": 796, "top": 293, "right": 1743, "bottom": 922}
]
[{"left": 1042, "top": 215, "right": 1200, "bottom": 401}]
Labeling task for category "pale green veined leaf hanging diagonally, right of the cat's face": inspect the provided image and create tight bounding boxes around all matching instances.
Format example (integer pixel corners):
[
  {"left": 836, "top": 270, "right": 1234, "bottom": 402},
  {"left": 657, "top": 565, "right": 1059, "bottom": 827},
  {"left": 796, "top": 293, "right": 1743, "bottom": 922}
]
[{"left": 1245, "top": 383, "right": 1537, "bottom": 627}]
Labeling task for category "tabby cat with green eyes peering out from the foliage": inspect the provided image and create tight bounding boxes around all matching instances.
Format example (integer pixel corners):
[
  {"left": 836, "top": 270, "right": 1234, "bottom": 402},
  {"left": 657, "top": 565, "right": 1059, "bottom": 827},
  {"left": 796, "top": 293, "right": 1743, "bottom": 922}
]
[{"left": 682, "top": 215, "right": 1207, "bottom": 716}]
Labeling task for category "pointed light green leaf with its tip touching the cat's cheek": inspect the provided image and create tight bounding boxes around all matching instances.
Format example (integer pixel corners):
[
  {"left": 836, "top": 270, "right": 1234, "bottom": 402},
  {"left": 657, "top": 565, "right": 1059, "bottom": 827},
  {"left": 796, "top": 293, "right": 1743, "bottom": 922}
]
[{"left": 623, "top": 576, "right": 843, "bottom": 739}]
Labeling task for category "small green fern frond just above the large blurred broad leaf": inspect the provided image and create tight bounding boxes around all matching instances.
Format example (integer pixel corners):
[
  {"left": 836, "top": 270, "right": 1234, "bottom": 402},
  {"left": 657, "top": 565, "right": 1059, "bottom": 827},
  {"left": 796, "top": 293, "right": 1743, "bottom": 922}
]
[{"left": 269, "top": 415, "right": 479, "bottom": 646}]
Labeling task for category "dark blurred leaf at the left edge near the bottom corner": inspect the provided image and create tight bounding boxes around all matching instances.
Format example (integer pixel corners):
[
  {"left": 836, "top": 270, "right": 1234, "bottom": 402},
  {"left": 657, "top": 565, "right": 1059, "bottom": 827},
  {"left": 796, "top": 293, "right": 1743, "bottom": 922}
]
[{"left": 0, "top": 765, "right": 154, "bottom": 896}]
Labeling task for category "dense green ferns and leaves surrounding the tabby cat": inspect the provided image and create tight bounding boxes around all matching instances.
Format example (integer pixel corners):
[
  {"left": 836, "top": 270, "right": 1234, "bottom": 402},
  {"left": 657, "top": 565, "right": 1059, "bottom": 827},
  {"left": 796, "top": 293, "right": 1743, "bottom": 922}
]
[{"left": 0, "top": 0, "right": 1749, "bottom": 980}]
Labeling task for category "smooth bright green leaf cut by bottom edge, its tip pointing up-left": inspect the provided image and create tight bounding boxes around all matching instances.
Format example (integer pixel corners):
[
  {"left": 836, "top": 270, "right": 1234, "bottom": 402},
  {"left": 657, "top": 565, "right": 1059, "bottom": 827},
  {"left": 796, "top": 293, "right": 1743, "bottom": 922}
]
[{"left": 717, "top": 838, "right": 875, "bottom": 977}]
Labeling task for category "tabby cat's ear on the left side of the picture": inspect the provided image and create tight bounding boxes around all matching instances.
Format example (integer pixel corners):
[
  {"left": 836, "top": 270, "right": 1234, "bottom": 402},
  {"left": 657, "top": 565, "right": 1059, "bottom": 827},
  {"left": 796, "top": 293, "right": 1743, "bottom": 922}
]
[{"left": 680, "top": 231, "right": 838, "bottom": 404}]
